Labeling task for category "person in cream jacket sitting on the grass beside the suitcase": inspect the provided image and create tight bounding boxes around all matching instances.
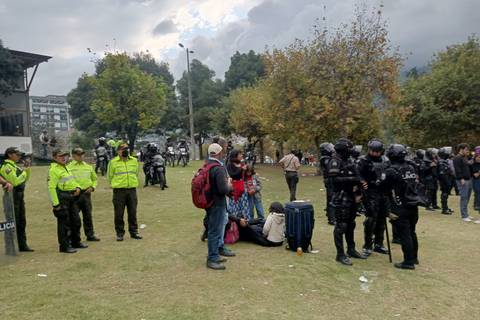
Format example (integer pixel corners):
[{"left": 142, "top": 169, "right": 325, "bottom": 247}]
[{"left": 229, "top": 202, "right": 285, "bottom": 247}]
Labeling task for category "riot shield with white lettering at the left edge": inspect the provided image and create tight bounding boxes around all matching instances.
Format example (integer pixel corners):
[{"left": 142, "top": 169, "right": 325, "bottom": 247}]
[{"left": 0, "top": 191, "right": 18, "bottom": 258}]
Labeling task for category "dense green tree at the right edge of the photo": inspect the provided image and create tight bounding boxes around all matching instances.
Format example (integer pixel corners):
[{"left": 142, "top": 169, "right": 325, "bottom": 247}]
[{"left": 397, "top": 36, "right": 480, "bottom": 146}]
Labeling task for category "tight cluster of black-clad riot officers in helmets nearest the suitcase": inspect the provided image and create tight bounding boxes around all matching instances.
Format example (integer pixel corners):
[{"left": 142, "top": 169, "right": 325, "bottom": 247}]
[{"left": 320, "top": 138, "right": 436, "bottom": 269}]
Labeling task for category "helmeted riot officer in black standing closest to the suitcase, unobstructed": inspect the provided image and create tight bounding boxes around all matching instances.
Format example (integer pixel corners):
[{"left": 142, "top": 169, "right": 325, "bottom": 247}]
[{"left": 327, "top": 138, "right": 366, "bottom": 266}]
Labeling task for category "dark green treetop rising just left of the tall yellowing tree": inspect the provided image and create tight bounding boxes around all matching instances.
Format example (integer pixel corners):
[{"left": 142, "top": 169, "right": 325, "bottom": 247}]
[{"left": 225, "top": 50, "right": 265, "bottom": 91}]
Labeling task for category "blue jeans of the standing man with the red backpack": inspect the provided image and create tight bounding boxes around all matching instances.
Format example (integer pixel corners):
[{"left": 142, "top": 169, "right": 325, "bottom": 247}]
[{"left": 206, "top": 207, "right": 227, "bottom": 261}]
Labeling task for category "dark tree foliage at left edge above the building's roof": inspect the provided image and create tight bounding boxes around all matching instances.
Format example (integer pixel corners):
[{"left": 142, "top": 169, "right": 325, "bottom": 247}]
[{"left": 0, "top": 40, "right": 23, "bottom": 97}]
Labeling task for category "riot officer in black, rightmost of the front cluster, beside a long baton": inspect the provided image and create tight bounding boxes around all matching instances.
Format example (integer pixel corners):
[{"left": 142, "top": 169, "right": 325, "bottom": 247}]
[{"left": 386, "top": 144, "right": 418, "bottom": 269}]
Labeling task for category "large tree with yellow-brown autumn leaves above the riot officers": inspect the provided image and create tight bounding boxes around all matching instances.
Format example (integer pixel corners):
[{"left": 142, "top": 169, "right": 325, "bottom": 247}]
[{"left": 258, "top": 3, "right": 401, "bottom": 149}]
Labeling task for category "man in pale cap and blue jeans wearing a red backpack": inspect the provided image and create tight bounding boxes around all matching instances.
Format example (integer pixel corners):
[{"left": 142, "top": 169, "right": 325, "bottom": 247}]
[{"left": 192, "top": 143, "right": 235, "bottom": 270}]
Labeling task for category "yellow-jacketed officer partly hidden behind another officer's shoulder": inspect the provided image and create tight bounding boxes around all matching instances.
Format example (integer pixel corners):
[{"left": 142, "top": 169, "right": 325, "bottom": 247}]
[{"left": 67, "top": 148, "right": 100, "bottom": 241}]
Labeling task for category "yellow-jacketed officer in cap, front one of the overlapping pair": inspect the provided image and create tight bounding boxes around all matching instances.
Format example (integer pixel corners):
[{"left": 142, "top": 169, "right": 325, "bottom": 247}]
[{"left": 48, "top": 149, "right": 88, "bottom": 253}]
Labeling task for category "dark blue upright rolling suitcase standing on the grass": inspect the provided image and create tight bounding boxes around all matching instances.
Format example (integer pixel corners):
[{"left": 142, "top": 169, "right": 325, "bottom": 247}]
[{"left": 285, "top": 201, "right": 315, "bottom": 252}]
